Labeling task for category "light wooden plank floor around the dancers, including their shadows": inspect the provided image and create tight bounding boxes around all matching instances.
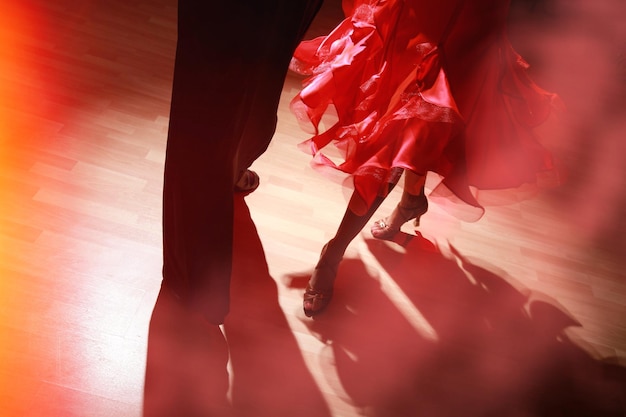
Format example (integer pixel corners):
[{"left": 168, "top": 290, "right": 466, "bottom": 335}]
[{"left": 0, "top": 0, "right": 626, "bottom": 417}]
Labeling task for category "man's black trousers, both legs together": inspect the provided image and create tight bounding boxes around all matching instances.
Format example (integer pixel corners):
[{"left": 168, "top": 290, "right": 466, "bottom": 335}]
[{"left": 163, "top": 0, "right": 319, "bottom": 324}]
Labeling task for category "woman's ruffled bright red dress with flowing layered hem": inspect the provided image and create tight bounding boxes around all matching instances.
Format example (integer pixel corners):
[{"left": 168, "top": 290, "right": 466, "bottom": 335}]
[{"left": 291, "top": 0, "right": 555, "bottom": 220}]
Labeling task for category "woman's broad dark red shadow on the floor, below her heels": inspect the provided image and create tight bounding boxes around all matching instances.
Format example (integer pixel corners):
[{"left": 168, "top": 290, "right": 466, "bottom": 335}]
[{"left": 290, "top": 232, "right": 626, "bottom": 417}]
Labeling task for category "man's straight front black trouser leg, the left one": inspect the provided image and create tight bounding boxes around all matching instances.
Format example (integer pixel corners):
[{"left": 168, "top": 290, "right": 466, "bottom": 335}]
[{"left": 163, "top": 0, "right": 252, "bottom": 324}]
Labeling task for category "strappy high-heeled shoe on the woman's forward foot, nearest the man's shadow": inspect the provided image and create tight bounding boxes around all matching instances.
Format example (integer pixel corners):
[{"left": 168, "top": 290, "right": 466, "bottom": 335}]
[{"left": 302, "top": 243, "right": 342, "bottom": 317}]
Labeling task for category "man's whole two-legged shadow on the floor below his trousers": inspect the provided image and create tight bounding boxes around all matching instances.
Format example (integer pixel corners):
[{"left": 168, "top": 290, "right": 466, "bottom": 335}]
[{"left": 144, "top": 198, "right": 330, "bottom": 417}]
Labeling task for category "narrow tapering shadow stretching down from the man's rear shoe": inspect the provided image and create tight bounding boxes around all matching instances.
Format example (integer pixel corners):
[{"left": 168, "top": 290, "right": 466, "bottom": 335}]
[{"left": 224, "top": 199, "right": 330, "bottom": 417}]
